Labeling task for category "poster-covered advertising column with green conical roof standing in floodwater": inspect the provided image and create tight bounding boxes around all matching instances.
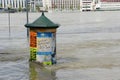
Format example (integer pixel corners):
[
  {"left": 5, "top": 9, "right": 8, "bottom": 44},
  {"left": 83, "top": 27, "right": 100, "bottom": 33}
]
[{"left": 25, "top": 13, "right": 59, "bottom": 65}]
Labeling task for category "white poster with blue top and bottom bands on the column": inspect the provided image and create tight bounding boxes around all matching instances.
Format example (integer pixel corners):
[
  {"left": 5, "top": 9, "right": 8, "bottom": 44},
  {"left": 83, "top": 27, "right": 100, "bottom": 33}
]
[{"left": 37, "top": 32, "right": 52, "bottom": 55}]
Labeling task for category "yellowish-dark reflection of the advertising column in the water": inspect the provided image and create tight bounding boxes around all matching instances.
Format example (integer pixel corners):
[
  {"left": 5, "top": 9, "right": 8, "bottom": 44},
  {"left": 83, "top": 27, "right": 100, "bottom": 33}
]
[{"left": 29, "top": 62, "right": 56, "bottom": 80}]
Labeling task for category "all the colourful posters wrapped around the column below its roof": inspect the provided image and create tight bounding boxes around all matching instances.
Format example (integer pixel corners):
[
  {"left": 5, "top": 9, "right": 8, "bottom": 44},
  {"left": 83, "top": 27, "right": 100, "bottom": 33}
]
[{"left": 30, "top": 31, "right": 56, "bottom": 65}]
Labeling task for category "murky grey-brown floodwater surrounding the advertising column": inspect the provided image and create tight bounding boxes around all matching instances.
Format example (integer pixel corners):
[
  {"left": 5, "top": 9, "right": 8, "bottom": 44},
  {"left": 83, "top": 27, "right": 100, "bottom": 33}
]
[{"left": 0, "top": 11, "right": 120, "bottom": 80}]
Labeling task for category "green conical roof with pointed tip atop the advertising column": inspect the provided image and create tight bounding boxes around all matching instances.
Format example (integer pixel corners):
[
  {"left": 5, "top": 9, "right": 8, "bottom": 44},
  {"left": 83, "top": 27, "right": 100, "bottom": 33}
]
[{"left": 25, "top": 12, "right": 59, "bottom": 28}]
